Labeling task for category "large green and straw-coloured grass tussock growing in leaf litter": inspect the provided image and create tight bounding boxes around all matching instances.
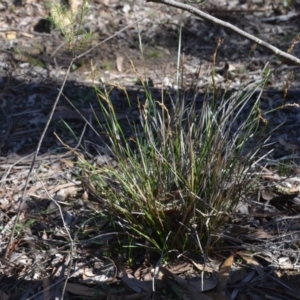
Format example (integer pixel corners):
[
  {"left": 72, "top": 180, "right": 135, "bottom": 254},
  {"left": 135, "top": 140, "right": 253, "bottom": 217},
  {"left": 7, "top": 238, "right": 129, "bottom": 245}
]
[{"left": 77, "top": 74, "right": 270, "bottom": 253}]
